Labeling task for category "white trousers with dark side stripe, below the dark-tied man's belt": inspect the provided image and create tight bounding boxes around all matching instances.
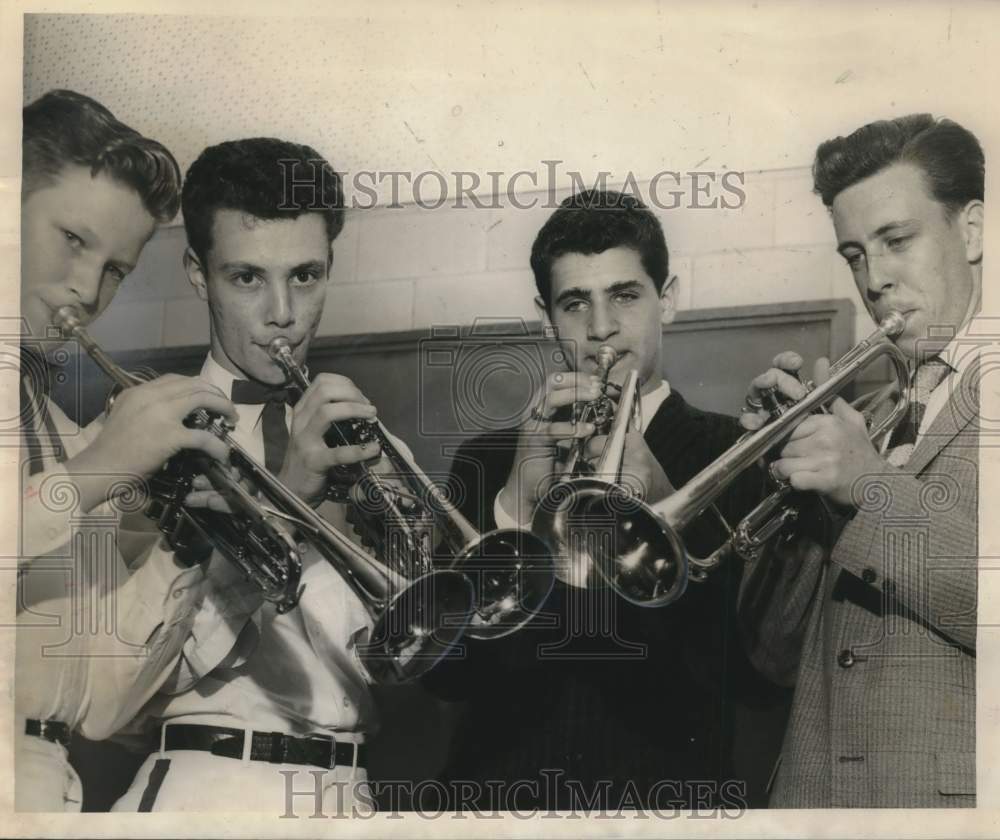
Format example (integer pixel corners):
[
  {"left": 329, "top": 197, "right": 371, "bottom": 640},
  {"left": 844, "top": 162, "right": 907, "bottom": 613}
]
[{"left": 111, "top": 750, "right": 375, "bottom": 819}]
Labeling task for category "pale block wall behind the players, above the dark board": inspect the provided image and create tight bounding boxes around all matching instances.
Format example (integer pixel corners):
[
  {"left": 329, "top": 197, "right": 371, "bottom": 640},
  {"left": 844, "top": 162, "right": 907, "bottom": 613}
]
[{"left": 88, "top": 168, "right": 870, "bottom": 350}]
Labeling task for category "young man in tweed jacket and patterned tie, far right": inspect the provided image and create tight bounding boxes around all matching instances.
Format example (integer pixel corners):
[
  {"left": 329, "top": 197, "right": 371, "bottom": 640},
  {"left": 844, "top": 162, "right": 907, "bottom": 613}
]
[{"left": 741, "top": 114, "right": 984, "bottom": 808}]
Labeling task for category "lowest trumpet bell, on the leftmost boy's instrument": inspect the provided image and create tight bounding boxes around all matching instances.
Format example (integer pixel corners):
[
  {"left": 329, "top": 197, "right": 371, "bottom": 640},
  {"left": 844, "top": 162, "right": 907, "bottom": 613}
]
[{"left": 358, "top": 571, "right": 475, "bottom": 685}]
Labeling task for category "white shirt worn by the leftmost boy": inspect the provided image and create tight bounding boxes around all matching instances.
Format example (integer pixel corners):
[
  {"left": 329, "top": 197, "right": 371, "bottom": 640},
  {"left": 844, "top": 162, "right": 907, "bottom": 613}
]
[{"left": 9, "top": 348, "right": 204, "bottom": 739}]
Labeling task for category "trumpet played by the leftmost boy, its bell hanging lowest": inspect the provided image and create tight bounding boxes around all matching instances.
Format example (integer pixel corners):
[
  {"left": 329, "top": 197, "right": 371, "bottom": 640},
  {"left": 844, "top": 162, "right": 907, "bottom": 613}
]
[{"left": 55, "top": 307, "right": 472, "bottom": 684}]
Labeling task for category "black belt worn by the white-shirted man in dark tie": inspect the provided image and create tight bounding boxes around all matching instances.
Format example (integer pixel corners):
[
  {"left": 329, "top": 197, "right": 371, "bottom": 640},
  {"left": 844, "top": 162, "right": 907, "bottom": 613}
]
[{"left": 163, "top": 723, "right": 367, "bottom": 769}]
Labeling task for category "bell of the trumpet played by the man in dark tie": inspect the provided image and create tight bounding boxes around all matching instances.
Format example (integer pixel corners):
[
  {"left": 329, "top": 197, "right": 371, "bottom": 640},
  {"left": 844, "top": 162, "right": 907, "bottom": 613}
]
[{"left": 455, "top": 528, "right": 555, "bottom": 639}]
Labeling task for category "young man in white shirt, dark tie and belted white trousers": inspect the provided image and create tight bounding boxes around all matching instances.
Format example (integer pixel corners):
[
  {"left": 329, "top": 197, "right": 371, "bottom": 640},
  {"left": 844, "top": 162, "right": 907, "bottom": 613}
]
[{"left": 115, "top": 138, "right": 379, "bottom": 815}]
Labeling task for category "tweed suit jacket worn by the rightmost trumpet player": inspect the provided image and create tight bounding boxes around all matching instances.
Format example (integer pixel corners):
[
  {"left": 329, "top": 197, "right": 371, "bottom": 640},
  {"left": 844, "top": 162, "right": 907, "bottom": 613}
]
[{"left": 738, "top": 365, "right": 979, "bottom": 808}]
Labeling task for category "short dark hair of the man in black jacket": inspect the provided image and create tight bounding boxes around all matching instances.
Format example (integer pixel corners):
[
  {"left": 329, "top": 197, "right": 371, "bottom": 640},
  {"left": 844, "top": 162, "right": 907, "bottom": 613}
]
[{"left": 531, "top": 190, "right": 670, "bottom": 309}]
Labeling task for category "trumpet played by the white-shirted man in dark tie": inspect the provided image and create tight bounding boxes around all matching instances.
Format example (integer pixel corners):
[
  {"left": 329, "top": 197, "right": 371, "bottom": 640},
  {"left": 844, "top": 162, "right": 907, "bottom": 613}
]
[{"left": 268, "top": 337, "right": 554, "bottom": 639}]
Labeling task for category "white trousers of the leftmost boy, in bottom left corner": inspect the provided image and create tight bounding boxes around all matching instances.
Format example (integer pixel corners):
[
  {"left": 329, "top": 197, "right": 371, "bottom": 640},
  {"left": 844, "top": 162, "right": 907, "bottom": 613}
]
[{"left": 14, "top": 732, "right": 83, "bottom": 813}]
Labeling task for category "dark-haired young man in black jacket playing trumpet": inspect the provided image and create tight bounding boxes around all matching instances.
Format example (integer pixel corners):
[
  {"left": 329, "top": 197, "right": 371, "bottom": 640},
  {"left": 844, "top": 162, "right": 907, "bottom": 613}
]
[{"left": 427, "top": 190, "right": 772, "bottom": 809}]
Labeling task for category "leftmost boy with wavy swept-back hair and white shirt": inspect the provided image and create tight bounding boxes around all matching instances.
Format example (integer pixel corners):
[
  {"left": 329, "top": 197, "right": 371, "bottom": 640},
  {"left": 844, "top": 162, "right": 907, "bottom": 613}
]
[{"left": 14, "top": 91, "right": 235, "bottom": 811}]
